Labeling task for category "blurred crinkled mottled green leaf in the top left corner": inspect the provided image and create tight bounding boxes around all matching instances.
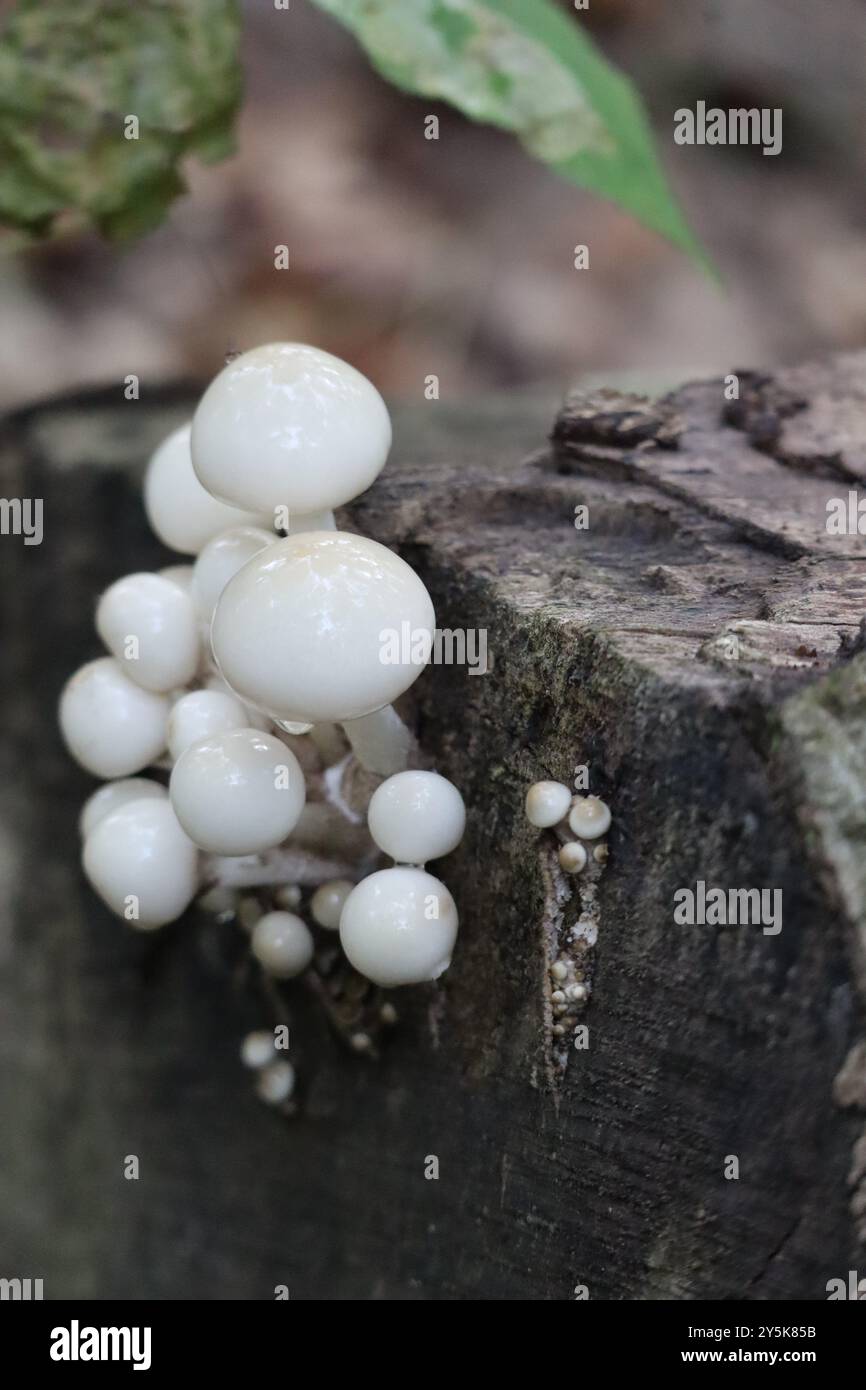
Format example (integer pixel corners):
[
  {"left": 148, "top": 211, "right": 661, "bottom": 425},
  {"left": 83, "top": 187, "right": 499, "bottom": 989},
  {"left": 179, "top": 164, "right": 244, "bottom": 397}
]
[{"left": 0, "top": 0, "right": 240, "bottom": 236}]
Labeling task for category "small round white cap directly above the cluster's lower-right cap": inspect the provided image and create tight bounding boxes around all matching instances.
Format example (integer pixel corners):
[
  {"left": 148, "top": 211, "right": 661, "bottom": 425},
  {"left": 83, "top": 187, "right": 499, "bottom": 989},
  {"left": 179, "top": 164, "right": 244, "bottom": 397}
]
[{"left": 367, "top": 771, "right": 466, "bottom": 865}]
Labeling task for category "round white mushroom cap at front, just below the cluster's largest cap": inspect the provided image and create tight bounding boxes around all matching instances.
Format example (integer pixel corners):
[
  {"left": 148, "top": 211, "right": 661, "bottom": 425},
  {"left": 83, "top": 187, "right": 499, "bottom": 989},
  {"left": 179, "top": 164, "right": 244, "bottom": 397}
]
[{"left": 168, "top": 728, "right": 306, "bottom": 856}]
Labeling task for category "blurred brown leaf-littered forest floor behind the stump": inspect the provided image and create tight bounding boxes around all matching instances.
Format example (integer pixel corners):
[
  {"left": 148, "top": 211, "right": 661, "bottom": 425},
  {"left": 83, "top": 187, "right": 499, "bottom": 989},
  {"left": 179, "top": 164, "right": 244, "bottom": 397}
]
[{"left": 0, "top": 0, "right": 866, "bottom": 409}]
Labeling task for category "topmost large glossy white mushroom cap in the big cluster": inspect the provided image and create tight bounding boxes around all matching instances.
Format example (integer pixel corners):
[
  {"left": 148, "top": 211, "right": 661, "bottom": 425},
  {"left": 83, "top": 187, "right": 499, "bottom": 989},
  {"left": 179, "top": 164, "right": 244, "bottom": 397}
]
[{"left": 192, "top": 343, "right": 391, "bottom": 517}]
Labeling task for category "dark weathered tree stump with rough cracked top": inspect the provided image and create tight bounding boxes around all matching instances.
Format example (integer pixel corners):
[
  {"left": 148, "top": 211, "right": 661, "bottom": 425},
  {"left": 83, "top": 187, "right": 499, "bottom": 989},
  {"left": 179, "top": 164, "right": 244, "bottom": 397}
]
[{"left": 0, "top": 356, "right": 866, "bottom": 1300}]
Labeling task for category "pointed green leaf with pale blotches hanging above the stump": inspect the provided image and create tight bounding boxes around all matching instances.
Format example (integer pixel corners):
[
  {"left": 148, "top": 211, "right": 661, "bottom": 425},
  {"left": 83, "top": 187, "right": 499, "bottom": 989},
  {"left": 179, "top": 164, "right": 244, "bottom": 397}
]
[{"left": 314, "top": 0, "right": 713, "bottom": 272}]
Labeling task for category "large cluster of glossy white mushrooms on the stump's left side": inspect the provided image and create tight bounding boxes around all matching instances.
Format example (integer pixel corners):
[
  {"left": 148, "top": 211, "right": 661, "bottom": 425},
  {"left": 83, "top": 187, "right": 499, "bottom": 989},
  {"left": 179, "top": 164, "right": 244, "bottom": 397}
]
[{"left": 60, "top": 343, "right": 466, "bottom": 1050}]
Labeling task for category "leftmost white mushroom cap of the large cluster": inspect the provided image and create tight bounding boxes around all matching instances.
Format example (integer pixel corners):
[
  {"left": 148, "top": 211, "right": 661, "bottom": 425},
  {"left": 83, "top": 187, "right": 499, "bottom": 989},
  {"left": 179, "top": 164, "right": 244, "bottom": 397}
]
[{"left": 60, "top": 656, "right": 171, "bottom": 778}]
